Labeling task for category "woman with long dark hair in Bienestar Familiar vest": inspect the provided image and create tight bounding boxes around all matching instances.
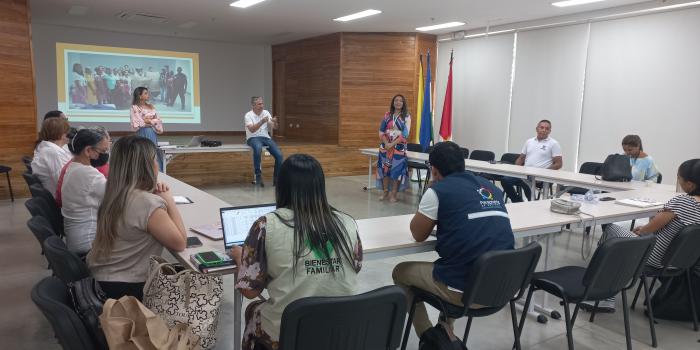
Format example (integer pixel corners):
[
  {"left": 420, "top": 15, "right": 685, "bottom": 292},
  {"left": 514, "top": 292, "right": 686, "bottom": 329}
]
[{"left": 231, "top": 154, "right": 362, "bottom": 350}]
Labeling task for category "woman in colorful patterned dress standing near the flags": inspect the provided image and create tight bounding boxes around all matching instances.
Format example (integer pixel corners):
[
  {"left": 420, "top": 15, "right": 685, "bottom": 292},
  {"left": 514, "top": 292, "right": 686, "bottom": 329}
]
[{"left": 377, "top": 95, "right": 411, "bottom": 203}]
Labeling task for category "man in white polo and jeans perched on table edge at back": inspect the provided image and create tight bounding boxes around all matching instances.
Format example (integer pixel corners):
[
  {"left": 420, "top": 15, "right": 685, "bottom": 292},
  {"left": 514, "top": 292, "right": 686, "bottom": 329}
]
[{"left": 245, "top": 96, "right": 284, "bottom": 187}]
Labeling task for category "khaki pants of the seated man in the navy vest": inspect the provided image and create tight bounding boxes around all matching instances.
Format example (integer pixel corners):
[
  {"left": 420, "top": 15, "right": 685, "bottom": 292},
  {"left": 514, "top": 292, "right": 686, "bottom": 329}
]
[{"left": 391, "top": 261, "right": 462, "bottom": 337}]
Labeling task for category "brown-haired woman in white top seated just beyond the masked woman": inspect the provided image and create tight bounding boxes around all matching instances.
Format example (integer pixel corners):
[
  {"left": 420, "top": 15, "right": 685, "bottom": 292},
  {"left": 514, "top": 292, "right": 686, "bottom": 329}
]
[{"left": 32, "top": 118, "right": 71, "bottom": 196}]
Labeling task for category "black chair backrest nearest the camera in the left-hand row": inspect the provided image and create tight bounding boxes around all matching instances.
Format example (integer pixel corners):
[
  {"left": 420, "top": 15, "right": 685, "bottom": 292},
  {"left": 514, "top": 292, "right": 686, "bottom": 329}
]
[{"left": 31, "top": 277, "right": 97, "bottom": 350}]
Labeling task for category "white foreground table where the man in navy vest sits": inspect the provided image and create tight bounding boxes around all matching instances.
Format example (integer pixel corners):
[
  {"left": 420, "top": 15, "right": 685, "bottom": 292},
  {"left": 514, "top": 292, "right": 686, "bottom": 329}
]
[{"left": 159, "top": 172, "right": 677, "bottom": 349}]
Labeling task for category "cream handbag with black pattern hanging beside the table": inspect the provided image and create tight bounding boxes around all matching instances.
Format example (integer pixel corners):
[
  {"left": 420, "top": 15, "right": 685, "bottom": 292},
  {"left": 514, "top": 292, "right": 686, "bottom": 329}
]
[{"left": 143, "top": 256, "right": 223, "bottom": 349}]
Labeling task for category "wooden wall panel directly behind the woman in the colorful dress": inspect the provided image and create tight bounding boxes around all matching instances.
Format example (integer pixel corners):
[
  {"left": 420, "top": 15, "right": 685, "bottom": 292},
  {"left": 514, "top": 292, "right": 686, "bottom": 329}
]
[{"left": 338, "top": 33, "right": 436, "bottom": 147}]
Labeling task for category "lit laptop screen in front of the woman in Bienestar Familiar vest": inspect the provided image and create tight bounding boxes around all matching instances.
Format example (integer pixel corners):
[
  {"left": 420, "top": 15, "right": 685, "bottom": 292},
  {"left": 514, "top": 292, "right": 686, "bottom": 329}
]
[{"left": 219, "top": 203, "right": 277, "bottom": 253}]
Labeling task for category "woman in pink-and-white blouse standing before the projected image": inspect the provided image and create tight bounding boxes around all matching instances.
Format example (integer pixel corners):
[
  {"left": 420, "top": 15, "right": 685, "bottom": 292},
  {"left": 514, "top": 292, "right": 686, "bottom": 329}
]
[{"left": 129, "top": 86, "right": 163, "bottom": 171}]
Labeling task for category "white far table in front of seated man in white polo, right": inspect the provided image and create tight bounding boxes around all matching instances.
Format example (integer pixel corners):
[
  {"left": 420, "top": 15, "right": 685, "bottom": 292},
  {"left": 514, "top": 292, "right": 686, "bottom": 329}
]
[{"left": 360, "top": 148, "right": 675, "bottom": 200}]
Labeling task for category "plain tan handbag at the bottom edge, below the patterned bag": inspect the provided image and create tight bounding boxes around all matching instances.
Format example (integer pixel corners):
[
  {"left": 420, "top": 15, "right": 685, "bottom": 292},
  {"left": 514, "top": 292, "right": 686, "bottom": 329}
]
[{"left": 100, "top": 296, "right": 202, "bottom": 350}]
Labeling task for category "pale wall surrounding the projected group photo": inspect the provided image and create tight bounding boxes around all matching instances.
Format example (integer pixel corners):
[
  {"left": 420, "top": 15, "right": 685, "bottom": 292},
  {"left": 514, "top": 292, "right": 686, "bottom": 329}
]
[{"left": 32, "top": 23, "right": 272, "bottom": 131}]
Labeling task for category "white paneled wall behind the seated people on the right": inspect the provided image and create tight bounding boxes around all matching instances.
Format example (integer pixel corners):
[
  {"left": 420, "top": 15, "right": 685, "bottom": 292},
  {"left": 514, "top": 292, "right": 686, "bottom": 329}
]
[{"left": 435, "top": 8, "right": 700, "bottom": 183}]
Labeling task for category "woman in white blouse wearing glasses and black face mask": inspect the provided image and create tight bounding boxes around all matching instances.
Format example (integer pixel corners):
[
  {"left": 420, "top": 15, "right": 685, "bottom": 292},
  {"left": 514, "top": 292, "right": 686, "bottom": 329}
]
[{"left": 60, "top": 128, "right": 109, "bottom": 255}]
